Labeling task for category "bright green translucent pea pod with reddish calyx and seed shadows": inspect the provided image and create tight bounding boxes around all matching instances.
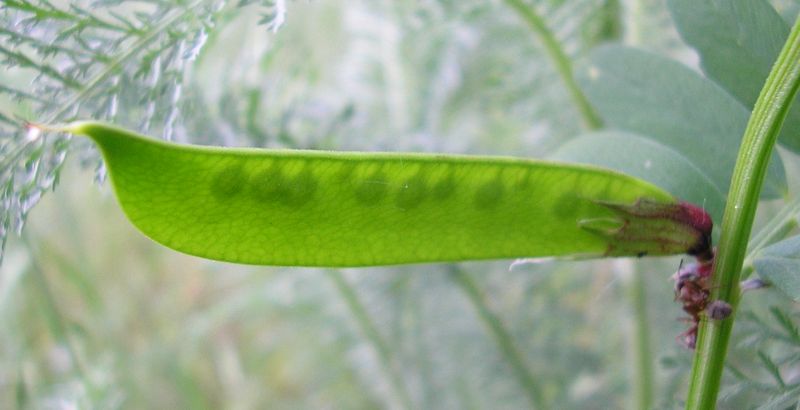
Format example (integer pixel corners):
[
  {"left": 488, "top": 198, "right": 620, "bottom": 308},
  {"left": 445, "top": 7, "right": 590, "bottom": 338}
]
[{"left": 59, "top": 122, "right": 704, "bottom": 266}]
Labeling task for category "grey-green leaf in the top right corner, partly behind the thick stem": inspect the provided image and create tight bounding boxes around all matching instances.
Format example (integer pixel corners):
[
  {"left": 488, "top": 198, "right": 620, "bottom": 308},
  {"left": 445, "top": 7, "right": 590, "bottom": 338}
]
[{"left": 669, "top": 0, "right": 800, "bottom": 152}]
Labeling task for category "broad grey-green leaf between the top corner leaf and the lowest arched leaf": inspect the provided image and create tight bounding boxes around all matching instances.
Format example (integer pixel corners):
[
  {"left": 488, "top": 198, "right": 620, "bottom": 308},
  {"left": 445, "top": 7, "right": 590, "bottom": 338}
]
[{"left": 578, "top": 46, "right": 786, "bottom": 198}]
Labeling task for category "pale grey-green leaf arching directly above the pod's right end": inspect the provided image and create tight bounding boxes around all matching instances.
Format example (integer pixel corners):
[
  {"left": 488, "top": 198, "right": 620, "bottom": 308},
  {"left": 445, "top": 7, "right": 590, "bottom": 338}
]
[{"left": 552, "top": 131, "right": 725, "bottom": 221}]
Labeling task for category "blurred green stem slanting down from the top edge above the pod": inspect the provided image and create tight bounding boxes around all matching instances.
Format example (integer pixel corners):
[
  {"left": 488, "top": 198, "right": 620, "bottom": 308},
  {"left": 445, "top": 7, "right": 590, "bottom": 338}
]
[{"left": 505, "top": 0, "right": 602, "bottom": 129}]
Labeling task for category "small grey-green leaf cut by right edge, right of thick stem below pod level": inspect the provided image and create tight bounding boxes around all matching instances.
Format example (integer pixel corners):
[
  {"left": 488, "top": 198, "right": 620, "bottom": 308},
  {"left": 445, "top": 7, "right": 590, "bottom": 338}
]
[{"left": 753, "top": 235, "right": 800, "bottom": 302}]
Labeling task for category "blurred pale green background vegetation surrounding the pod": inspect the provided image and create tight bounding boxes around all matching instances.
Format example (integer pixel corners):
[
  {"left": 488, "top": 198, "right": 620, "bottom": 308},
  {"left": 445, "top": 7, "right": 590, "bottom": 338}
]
[{"left": 0, "top": 0, "right": 800, "bottom": 409}]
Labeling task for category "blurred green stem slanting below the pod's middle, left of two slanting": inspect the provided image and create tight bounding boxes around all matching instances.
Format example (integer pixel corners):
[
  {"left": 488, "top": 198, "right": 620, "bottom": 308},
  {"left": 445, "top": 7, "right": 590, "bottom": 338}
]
[{"left": 326, "top": 270, "right": 414, "bottom": 409}]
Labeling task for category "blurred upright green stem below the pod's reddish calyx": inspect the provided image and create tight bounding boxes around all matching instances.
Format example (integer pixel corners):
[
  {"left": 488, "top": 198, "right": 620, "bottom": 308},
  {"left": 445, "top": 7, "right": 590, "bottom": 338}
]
[{"left": 625, "top": 261, "right": 653, "bottom": 409}]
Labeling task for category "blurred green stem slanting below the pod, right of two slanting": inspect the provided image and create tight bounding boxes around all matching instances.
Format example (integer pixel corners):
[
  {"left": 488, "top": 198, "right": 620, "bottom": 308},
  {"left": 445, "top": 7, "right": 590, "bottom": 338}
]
[{"left": 450, "top": 266, "right": 549, "bottom": 409}]
